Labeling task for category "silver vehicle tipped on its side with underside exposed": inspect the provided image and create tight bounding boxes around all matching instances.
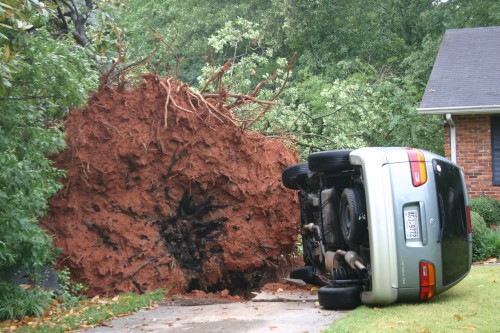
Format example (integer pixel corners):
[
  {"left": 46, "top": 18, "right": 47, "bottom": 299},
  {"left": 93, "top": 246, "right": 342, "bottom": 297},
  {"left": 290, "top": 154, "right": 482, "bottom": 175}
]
[{"left": 282, "top": 147, "right": 472, "bottom": 309}]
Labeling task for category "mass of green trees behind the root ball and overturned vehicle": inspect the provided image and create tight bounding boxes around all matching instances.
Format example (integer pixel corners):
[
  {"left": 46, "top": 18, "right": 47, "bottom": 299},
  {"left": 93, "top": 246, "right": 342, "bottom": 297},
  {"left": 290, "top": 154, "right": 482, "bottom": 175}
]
[{"left": 124, "top": 0, "right": 479, "bottom": 155}]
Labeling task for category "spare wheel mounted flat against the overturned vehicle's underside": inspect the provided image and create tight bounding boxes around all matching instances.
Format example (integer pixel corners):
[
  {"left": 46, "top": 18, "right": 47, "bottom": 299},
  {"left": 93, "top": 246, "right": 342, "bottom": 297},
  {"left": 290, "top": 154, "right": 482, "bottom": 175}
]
[{"left": 340, "top": 187, "right": 367, "bottom": 245}]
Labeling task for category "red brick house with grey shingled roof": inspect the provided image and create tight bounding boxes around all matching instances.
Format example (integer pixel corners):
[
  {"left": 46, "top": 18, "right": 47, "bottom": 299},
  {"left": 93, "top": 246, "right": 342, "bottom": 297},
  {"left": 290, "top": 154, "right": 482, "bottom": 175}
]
[{"left": 417, "top": 27, "right": 500, "bottom": 199}]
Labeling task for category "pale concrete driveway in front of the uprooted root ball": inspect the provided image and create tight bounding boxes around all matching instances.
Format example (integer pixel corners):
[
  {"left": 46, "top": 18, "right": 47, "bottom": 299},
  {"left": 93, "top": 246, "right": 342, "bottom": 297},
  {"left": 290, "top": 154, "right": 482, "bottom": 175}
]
[{"left": 85, "top": 290, "right": 345, "bottom": 333}]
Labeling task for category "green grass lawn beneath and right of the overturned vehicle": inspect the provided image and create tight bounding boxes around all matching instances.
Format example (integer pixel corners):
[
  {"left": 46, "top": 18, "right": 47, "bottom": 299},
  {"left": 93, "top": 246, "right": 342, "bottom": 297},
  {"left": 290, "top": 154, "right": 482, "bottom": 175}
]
[{"left": 324, "top": 265, "right": 500, "bottom": 333}]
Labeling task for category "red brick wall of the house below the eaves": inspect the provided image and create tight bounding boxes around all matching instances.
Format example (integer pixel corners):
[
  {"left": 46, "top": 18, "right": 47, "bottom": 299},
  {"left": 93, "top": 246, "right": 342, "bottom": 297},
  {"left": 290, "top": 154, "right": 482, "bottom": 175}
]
[{"left": 444, "top": 115, "right": 500, "bottom": 199}]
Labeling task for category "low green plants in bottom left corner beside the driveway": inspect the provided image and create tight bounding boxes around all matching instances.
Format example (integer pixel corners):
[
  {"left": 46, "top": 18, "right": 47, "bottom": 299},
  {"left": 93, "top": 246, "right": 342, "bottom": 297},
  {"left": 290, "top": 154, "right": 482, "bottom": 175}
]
[{"left": 0, "top": 281, "right": 53, "bottom": 321}]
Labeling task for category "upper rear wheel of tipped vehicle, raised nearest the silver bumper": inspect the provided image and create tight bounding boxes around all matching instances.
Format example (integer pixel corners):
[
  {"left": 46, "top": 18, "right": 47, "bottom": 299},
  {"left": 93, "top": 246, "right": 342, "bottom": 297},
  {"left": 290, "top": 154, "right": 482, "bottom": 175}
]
[{"left": 308, "top": 150, "right": 352, "bottom": 172}]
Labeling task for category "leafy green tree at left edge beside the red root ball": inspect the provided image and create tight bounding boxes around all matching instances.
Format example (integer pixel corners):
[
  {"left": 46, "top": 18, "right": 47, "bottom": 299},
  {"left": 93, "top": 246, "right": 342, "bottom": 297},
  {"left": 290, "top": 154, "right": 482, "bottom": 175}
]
[{"left": 0, "top": 29, "right": 96, "bottom": 268}]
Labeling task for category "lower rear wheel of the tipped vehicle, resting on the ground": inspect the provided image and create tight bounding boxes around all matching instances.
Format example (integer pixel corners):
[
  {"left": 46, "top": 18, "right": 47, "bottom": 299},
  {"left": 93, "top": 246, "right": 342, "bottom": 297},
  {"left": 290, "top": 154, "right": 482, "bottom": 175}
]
[{"left": 318, "top": 286, "right": 361, "bottom": 310}]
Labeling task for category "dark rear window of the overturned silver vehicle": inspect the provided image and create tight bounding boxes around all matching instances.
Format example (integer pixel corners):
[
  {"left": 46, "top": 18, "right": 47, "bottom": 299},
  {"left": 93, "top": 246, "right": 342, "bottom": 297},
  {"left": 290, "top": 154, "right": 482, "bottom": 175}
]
[{"left": 432, "top": 160, "right": 470, "bottom": 286}]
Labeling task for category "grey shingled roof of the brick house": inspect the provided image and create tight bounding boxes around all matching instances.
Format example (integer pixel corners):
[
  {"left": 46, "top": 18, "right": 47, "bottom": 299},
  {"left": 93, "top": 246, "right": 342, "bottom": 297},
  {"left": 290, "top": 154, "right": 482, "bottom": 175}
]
[{"left": 418, "top": 27, "right": 500, "bottom": 114}]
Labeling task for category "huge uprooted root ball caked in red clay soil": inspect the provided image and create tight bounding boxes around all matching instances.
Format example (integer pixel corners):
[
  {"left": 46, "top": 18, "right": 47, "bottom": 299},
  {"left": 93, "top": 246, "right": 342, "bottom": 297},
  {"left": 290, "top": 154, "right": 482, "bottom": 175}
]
[{"left": 41, "top": 75, "right": 300, "bottom": 295}]
